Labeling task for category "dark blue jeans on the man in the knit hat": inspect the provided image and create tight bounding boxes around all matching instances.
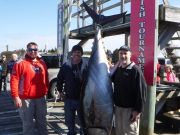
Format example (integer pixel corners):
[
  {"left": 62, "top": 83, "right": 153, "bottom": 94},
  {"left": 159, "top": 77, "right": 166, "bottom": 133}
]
[{"left": 64, "top": 99, "right": 84, "bottom": 135}]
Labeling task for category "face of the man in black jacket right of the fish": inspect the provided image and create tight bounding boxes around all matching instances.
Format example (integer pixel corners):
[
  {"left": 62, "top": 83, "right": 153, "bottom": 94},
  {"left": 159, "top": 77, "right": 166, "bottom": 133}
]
[{"left": 119, "top": 50, "right": 131, "bottom": 65}]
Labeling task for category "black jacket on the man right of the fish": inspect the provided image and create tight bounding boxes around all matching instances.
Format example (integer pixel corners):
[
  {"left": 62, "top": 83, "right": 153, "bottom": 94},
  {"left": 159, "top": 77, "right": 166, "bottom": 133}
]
[{"left": 112, "top": 63, "right": 147, "bottom": 112}]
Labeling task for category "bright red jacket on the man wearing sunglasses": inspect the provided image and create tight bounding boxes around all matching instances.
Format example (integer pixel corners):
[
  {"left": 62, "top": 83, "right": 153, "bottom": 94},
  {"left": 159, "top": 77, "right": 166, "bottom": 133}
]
[{"left": 10, "top": 57, "right": 49, "bottom": 99}]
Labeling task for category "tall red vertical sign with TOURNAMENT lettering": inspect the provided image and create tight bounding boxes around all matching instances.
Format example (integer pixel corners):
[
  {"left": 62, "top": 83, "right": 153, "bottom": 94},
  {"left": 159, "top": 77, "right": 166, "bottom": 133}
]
[{"left": 130, "top": 0, "right": 157, "bottom": 85}]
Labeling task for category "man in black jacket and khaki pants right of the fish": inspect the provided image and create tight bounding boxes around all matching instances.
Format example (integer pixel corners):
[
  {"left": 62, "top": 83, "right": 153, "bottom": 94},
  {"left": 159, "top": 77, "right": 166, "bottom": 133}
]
[{"left": 112, "top": 45, "right": 147, "bottom": 135}]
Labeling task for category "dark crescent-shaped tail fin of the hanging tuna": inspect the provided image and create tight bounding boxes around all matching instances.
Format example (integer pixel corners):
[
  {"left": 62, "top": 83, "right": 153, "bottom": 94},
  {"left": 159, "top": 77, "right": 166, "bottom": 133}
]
[{"left": 83, "top": 1, "right": 127, "bottom": 26}]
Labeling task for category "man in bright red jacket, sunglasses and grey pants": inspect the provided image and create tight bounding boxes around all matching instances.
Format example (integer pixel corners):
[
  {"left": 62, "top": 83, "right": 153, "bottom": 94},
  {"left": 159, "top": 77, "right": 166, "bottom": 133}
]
[{"left": 10, "top": 42, "right": 49, "bottom": 135}]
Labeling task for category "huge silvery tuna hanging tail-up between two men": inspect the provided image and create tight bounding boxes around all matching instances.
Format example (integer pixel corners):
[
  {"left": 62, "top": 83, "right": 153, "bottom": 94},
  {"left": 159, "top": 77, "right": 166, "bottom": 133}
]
[{"left": 83, "top": 2, "right": 126, "bottom": 135}]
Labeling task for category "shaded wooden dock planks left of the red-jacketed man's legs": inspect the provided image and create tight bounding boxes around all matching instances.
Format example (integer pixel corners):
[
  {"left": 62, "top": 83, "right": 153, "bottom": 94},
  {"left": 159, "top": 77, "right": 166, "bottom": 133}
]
[{"left": 0, "top": 91, "right": 22, "bottom": 135}]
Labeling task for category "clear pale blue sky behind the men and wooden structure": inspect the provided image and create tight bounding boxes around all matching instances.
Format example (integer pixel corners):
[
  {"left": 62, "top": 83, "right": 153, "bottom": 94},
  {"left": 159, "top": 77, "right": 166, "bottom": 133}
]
[{"left": 0, "top": 0, "right": 180, "bottom": 52}]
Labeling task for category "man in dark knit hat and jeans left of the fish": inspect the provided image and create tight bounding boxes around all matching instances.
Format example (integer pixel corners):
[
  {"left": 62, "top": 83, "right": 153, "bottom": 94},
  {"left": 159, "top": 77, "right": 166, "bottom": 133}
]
[{"left": 57, "top": 45, "right": 88, "bottom": 135}]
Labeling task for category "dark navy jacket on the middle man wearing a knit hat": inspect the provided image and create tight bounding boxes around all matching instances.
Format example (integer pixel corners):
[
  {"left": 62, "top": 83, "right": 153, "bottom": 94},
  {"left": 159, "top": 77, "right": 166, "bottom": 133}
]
[{"left": 57, "top": 59, "right": 88, "bottom": 100}]
